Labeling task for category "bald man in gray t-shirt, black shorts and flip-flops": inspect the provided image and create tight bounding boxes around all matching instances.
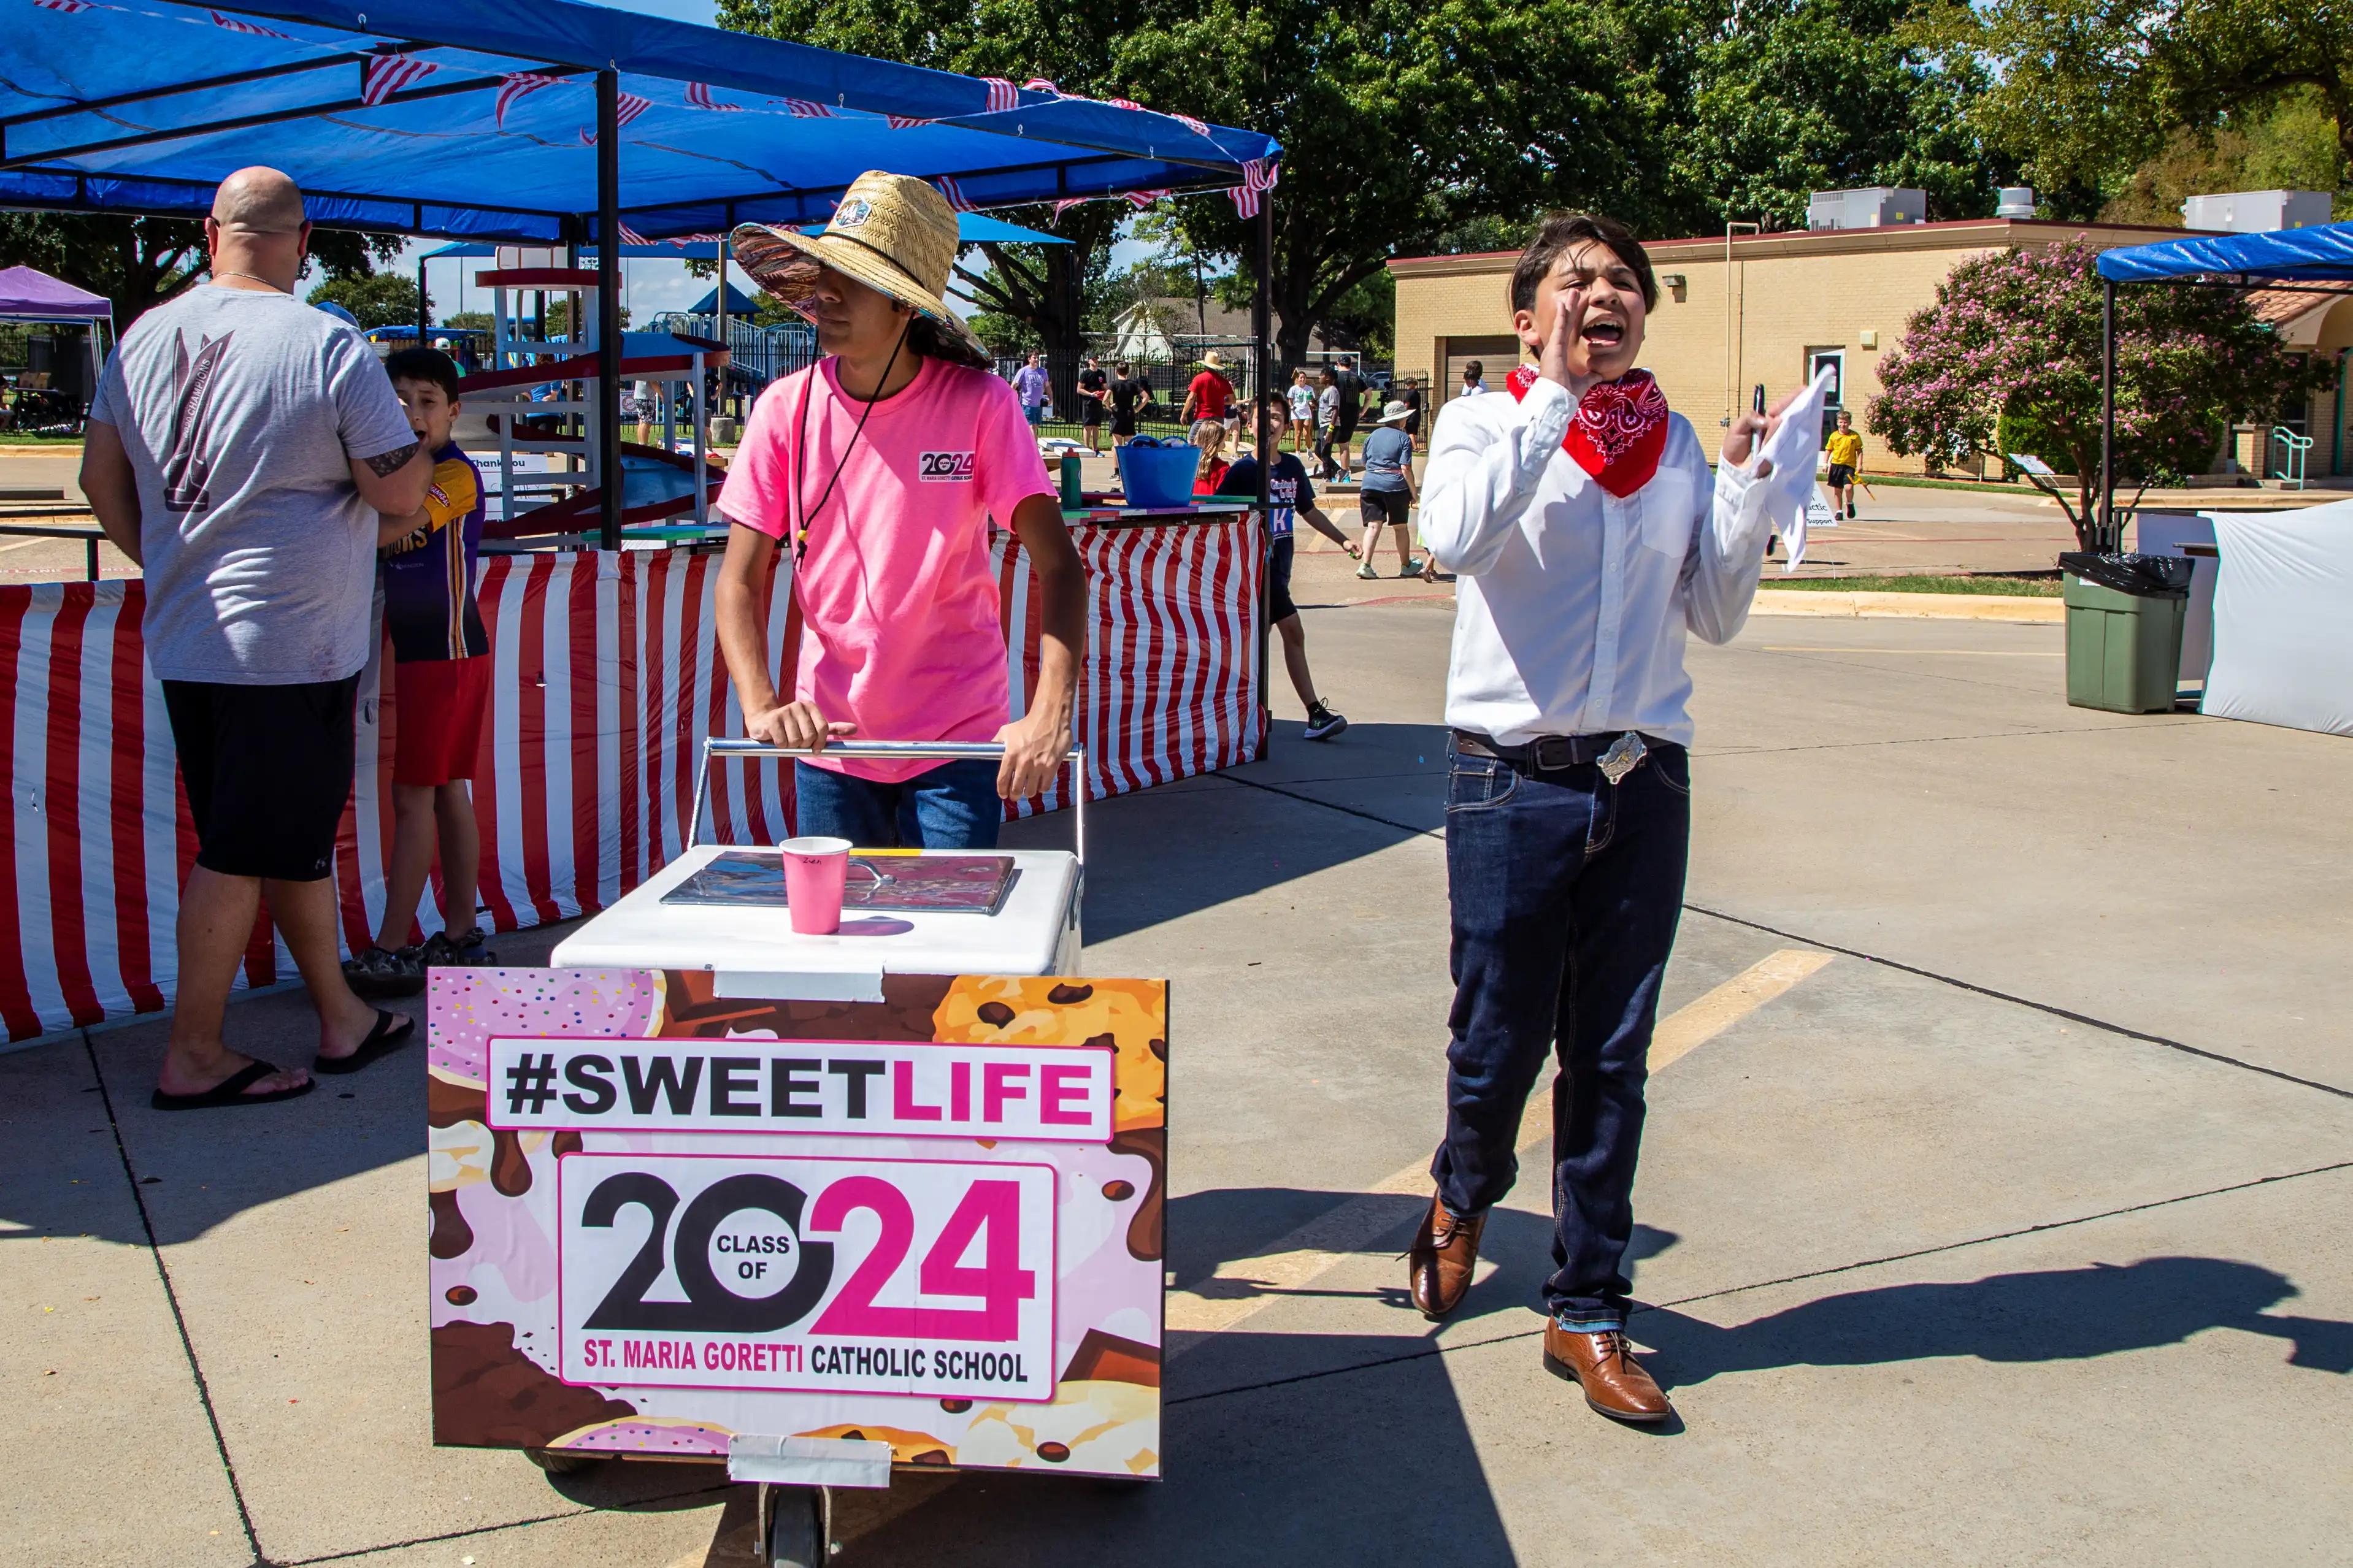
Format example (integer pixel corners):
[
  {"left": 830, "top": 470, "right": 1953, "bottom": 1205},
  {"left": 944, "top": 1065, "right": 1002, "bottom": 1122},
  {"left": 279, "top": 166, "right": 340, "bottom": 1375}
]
[{"left": 82, "top": 169, "right": 433, "bottom": 1109}]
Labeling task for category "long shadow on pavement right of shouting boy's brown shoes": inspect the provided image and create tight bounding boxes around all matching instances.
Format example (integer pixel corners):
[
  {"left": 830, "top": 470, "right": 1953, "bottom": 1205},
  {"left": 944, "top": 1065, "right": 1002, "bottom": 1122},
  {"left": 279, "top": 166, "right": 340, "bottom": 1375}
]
[{"left": 1635, "top": 1258, "right": 2353, "bottom": 1387}]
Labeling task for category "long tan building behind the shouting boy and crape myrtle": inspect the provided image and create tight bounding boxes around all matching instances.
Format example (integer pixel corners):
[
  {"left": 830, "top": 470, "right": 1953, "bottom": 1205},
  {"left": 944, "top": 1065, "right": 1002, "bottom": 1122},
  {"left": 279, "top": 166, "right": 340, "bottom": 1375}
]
[{"left": 1388, "top": 219, "right": 2324, "bottom": 477}]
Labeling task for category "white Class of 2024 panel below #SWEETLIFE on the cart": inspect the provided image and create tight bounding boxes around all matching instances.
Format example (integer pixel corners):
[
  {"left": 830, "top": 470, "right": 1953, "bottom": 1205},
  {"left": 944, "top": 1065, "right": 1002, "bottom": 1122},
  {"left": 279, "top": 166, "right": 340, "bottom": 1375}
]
[{"left": 555, "top": 1154, "right": 1054, "bottom": 1401}]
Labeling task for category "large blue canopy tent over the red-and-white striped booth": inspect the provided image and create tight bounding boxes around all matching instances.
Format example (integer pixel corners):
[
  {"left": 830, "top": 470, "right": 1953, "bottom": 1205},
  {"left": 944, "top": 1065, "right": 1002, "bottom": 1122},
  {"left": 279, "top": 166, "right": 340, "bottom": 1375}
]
[{"left": 0, "top": 0, "right": 1280, "bottom": 545}]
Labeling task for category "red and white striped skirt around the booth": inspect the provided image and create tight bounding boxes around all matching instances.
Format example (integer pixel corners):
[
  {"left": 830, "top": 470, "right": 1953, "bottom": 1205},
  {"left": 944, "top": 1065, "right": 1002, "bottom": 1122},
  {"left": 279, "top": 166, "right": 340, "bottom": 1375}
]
[{"left": 0, "top": 515, "right": 1266, "bottom": 1041}]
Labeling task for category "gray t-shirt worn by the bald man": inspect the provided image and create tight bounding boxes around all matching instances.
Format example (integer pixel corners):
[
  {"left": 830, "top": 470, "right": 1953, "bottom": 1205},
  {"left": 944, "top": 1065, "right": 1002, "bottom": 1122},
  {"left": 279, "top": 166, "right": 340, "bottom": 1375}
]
[{"left": 90, "top": 285, "right": 416, "bottom": 686}]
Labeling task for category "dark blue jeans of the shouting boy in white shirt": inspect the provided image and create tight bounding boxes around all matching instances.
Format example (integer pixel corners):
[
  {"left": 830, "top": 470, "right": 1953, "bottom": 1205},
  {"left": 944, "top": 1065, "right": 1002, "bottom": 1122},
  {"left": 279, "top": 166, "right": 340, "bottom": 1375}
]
[{"left": 1430, "top": 743, "right": 1692, "bottom": 1331}]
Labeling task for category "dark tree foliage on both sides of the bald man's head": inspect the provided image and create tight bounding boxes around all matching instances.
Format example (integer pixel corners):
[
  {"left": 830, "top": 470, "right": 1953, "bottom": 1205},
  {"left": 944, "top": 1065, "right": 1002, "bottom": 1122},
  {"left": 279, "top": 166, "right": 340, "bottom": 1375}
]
[{"left": 0, "top": 212, "right": 400, "bottom": 332}]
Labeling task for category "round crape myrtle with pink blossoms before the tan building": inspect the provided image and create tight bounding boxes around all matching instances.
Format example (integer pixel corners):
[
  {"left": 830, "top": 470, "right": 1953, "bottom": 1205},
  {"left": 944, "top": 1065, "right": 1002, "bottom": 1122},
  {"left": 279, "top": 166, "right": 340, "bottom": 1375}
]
[{"left": 1871, "top": 240, "right": 2332, "bottom": 550}]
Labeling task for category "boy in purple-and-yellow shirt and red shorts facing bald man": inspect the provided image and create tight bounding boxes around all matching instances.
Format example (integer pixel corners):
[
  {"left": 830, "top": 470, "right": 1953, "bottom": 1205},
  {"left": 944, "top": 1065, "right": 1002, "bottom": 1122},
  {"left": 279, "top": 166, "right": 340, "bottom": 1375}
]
[{"left": 344, "top": 348, "right": 489, "bottom": 996}]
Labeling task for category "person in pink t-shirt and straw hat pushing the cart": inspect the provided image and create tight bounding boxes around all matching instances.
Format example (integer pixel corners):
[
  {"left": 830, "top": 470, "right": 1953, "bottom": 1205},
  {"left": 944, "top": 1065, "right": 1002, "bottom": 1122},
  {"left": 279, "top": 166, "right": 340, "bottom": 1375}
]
[{"left": 718, "top": 172, "right": 1087, "bottom": 849}]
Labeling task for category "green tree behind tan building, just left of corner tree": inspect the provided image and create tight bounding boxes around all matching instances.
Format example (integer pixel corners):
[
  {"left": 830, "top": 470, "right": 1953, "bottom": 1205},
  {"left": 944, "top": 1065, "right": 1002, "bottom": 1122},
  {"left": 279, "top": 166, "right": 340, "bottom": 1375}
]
[{"left": 1675, "top": 0, "right": 2007, "bottom": 228}]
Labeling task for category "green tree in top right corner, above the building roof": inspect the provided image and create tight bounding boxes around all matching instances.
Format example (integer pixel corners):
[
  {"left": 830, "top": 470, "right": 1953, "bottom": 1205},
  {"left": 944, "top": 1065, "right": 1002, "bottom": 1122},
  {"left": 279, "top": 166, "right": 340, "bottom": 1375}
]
[{"left": 1916, "top": 0, "right": 2353, "bottom": 209}]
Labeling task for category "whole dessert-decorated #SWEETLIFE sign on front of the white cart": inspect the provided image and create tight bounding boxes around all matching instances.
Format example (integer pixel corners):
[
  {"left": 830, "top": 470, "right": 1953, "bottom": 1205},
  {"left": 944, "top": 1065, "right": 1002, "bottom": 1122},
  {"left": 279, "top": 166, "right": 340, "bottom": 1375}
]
[{"left": 426, "top": 968, "right": 1167, "bottom": 1476}]
